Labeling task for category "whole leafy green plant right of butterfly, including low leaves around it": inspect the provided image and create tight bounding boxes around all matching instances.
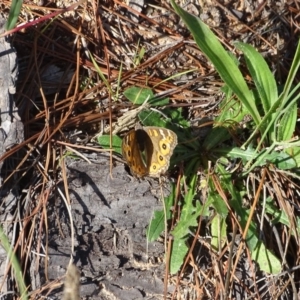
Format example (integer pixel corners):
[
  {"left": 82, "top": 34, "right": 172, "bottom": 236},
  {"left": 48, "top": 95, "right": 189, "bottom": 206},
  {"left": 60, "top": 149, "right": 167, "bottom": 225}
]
[{"left": 99, "top": 18, "right": 300, "bottom": 274}]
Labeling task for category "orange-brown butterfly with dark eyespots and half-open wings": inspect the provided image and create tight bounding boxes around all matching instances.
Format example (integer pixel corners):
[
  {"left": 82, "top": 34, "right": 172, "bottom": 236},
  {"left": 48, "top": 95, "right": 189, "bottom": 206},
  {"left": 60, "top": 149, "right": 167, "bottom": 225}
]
[{"left": 122, "top": 126, "right": 177, "bottom": 177}]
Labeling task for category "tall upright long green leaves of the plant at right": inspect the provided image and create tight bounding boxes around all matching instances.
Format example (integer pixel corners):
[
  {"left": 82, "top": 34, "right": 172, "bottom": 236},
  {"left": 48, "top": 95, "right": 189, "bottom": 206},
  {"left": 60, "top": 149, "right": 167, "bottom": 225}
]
[{"left": 172, "top": 1, "right": 300, "bottom": 172}]
